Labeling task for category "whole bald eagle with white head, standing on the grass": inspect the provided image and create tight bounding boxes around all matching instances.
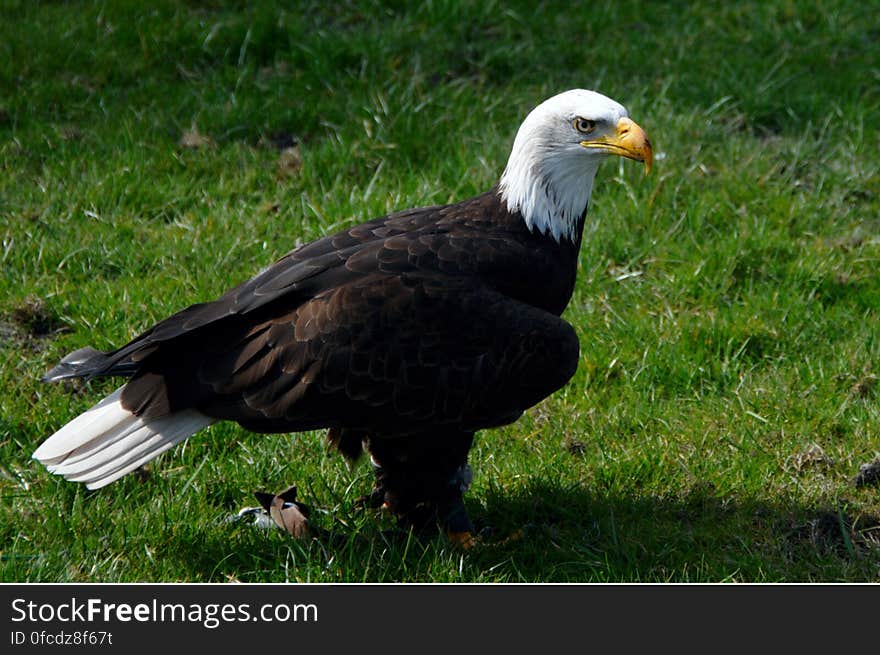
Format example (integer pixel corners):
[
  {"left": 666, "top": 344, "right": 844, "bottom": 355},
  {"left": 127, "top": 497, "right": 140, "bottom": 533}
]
[{"left": 33, "top": 89, "right": 652, "bottom": 544}]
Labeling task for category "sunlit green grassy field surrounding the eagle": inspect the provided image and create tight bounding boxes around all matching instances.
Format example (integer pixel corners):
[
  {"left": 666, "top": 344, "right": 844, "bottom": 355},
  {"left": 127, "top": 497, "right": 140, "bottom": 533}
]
[{"left": 0, "top": 0, "right": 880, "bottom": 582}]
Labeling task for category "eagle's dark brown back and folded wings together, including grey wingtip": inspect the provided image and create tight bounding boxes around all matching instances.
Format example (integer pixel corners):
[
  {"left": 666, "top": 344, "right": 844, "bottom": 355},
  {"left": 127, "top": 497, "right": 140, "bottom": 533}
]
[{"left": 47, "top": 192, "right": 577, "bottom": 432}]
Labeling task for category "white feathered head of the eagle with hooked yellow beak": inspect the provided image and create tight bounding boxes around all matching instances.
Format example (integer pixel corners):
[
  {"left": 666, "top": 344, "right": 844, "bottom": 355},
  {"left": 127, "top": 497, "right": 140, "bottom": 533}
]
[{"left": 499, "top": 89, "right": 653, "bottom": 241}]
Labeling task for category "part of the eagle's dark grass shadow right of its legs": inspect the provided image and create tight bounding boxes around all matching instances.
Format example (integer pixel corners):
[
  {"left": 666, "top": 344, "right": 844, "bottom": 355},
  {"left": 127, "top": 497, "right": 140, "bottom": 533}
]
[{"left": 460, "top": 483, "right": 880, "bottom": 582}]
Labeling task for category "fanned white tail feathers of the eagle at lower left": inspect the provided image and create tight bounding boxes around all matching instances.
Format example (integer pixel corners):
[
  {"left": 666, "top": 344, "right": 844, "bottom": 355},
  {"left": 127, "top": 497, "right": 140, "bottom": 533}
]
[{"left": 33, "top": 387, "right": 214, "bottom": 489}]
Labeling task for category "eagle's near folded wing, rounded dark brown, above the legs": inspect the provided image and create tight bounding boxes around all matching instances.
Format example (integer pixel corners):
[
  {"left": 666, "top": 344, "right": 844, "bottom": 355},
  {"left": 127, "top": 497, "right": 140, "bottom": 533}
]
[{"left": 123, "top": 272, "right": 578, "bottom": 435}]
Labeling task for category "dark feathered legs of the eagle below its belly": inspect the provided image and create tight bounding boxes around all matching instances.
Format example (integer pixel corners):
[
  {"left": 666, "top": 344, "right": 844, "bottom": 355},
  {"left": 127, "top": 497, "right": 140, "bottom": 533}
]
[{"left": 367, "top": 434, "right": 474, "bottom": 548}]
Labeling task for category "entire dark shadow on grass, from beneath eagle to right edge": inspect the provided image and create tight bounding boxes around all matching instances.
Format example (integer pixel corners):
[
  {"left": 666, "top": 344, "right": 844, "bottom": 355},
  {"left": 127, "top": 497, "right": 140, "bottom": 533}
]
[{"left": 148, "top": 483, "right": 880, "bottom": 582}]
